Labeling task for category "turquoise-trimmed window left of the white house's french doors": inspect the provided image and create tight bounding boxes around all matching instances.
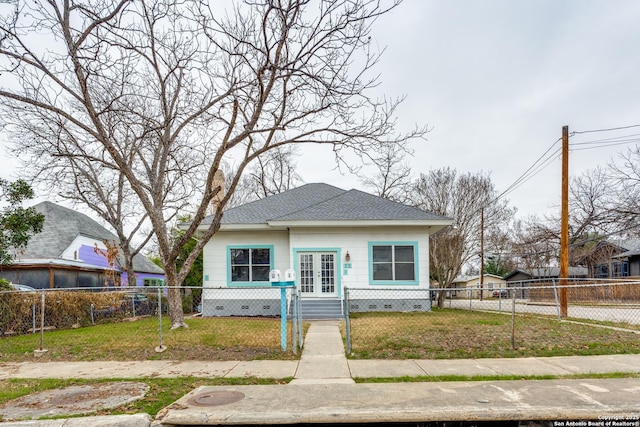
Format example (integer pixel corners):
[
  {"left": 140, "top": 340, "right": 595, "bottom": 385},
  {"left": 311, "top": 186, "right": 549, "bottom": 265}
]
[{"left": 229, "top": 247, "right": 272, "bottom": 283}]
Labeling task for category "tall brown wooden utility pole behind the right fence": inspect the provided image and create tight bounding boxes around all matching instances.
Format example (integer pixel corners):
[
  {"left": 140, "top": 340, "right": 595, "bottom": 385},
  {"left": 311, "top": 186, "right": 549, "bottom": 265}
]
[{"left": 559, "top": 126, "right": 569, "bottom": 319}]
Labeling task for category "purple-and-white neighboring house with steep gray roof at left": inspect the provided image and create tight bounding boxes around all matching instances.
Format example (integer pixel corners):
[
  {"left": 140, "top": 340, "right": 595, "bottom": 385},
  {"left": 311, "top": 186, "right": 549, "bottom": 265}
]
[{"left": 0, "top": 202, "right": 164, "bottom": 289}]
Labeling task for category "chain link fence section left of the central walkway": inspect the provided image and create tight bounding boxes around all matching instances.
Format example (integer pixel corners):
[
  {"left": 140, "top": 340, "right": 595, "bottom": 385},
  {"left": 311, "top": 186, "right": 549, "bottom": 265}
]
[{"left": 0, "top": 287, "right": 302, "bottom": 361}]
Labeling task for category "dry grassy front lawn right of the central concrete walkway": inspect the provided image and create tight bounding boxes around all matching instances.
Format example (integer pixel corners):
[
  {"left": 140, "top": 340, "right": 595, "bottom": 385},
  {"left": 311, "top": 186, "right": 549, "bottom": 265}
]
[{"left": 349, "top": 309, "right": 640, "bottom": 359}]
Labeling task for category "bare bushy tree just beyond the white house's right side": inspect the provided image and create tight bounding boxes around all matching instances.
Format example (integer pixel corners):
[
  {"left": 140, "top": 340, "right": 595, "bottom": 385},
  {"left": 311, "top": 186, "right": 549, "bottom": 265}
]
[{"left": 413, "top": 168, "right": 515, "bottom": 307}]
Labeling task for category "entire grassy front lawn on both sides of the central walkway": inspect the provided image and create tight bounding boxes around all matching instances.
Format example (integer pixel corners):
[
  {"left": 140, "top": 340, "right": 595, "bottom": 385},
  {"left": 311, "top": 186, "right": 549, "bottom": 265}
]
[{"left": 0, "top": 309, "right": 640, "bottom": 362}]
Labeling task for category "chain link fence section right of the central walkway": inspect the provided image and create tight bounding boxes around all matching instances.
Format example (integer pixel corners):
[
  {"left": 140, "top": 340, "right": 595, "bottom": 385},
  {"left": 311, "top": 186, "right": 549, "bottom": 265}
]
[{"left": 344, "top": 280, "right": 640, "bottom": 359}]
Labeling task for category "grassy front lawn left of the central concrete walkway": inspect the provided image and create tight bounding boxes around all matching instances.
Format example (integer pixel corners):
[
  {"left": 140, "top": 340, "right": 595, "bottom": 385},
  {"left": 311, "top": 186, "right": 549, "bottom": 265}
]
[{"left": 0, "top": 317, "right": 297, "bottom": 362}]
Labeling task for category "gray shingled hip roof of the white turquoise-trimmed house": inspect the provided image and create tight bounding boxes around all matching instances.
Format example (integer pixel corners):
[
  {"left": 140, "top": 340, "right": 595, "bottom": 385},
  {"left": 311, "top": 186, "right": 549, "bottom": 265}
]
[{"left": 204, "top": 184, "right": 448, "bottom": 224}]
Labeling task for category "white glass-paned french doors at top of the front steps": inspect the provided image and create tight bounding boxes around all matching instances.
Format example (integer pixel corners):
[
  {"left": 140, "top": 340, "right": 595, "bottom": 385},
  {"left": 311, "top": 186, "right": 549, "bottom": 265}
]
[{"left": 298, "top": 252, "right": 337, "bottom": 297}]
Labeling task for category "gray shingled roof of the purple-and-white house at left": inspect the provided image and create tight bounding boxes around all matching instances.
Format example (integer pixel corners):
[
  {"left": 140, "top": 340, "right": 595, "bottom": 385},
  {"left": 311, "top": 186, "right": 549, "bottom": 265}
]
[{"left": 20, "top": 202, "right": 164, "bottom": 274}]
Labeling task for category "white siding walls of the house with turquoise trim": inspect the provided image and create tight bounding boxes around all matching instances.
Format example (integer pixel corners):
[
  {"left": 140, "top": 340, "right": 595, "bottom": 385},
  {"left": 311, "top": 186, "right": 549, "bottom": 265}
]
[{"left": 202, "top": 227, "right": 431, "bottom": 316}]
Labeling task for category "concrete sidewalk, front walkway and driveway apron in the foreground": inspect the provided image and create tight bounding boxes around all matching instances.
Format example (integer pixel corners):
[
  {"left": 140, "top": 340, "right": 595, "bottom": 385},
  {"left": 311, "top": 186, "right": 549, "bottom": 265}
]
[{"left": 0, "top": 321, "right": 640, "bottom": 427}]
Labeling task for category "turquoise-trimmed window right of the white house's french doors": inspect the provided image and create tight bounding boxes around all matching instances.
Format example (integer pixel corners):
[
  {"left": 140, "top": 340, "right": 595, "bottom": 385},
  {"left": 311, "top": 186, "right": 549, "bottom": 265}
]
[{"left": 369, "top": 243, "right": 418, "bottom": 284}]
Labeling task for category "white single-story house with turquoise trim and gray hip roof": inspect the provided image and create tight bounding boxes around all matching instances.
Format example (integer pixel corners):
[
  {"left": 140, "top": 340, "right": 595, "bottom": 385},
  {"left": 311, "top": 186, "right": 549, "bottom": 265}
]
[{"left": 201, "top": 184, "right": 452, "bottom": 316}]
